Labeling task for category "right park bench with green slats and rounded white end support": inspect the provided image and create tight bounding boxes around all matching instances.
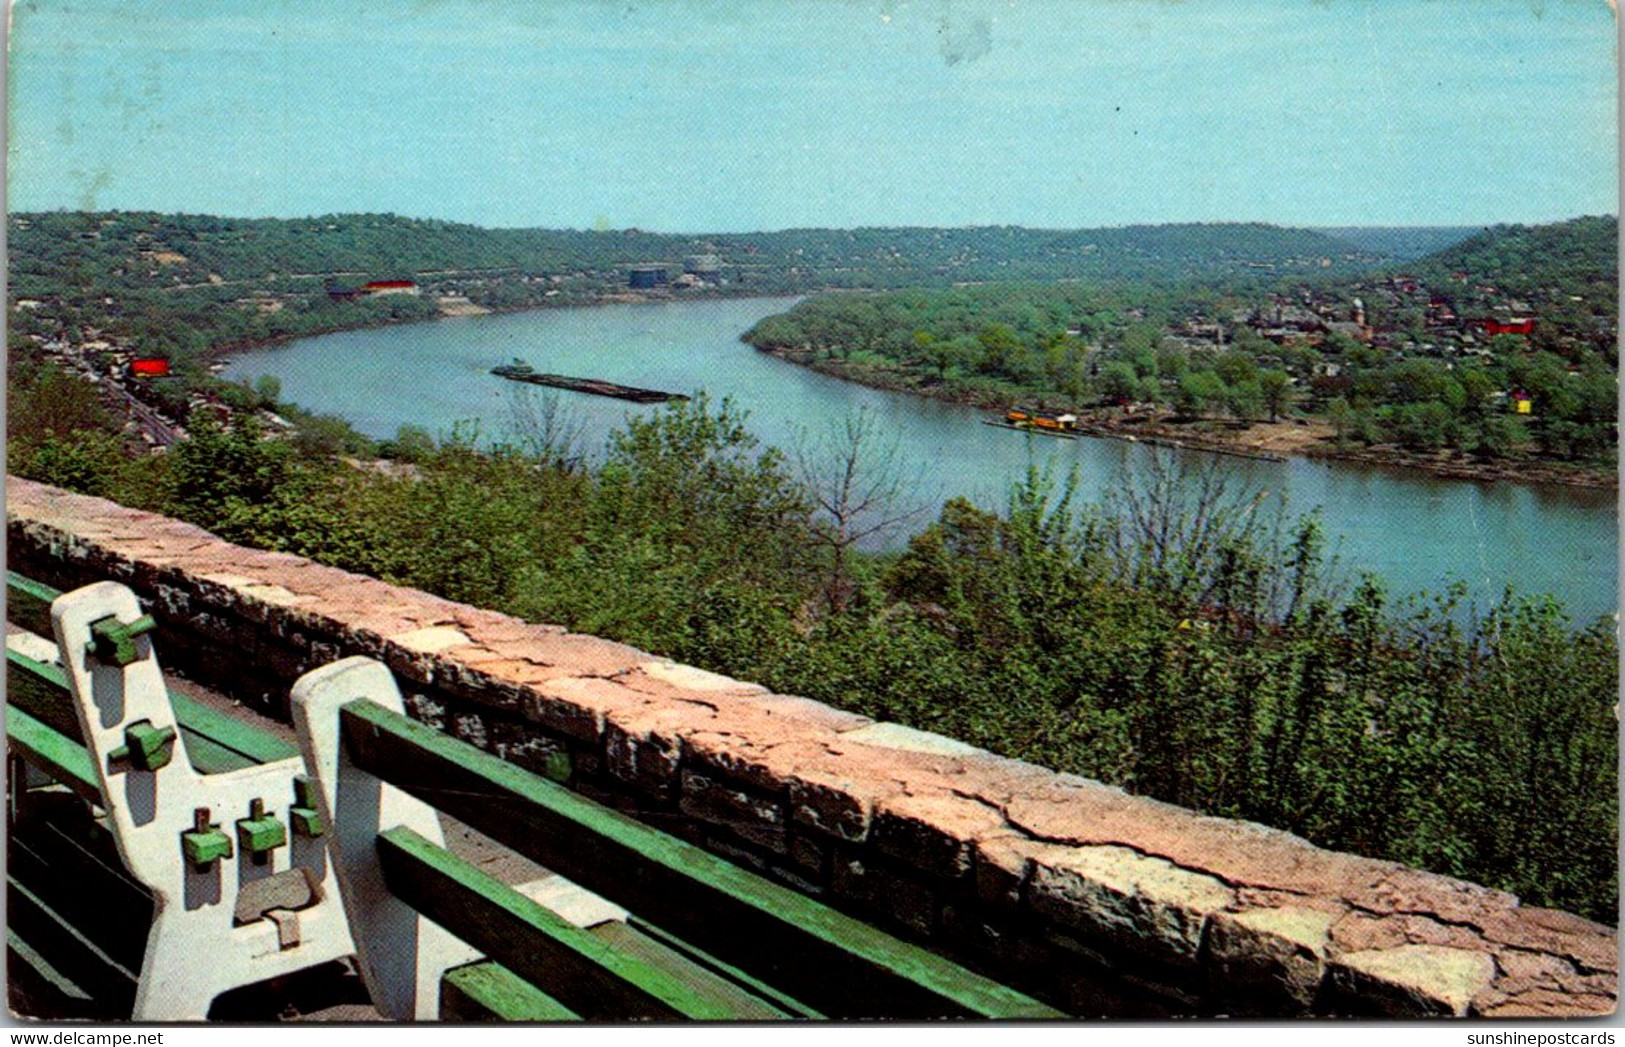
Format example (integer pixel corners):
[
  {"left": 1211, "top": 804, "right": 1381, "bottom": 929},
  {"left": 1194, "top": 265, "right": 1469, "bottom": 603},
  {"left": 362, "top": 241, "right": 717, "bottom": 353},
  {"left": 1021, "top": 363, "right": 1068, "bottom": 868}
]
[{"left": 293, "top": 658, "right": 1061, "bottom": 1021}]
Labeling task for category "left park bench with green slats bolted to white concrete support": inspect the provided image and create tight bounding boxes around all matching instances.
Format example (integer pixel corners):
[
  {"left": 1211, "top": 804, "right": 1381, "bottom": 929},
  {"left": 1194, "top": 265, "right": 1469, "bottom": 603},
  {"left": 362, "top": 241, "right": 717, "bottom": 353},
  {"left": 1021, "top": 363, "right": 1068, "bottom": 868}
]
[{"left": 7, "top": 574, "right": 353, "bottom": 1021}]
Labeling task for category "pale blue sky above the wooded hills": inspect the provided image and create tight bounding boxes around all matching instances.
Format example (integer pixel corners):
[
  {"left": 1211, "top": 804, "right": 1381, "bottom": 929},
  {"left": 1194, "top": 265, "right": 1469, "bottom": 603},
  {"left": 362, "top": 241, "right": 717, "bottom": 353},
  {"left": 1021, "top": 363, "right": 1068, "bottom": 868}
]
[{"left": 8, "top": 0, "right": 1619, "bottom": 231}]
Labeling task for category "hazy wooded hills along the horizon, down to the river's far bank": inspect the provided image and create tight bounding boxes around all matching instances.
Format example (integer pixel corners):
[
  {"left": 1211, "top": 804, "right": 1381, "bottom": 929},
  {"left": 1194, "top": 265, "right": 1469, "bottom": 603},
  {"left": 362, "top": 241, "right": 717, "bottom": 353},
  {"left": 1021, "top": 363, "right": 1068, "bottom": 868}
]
[{"left": 8, "top": 211, "right": 1380, "bottom": 378}]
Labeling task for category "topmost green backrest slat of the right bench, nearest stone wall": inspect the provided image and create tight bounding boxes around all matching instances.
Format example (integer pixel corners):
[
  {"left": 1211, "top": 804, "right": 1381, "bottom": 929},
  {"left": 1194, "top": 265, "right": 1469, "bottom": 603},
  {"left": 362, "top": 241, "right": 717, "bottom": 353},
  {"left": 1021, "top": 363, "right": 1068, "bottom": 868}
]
[{"left": 340, "top": 701, "right": 1063, "bottom": 1019}]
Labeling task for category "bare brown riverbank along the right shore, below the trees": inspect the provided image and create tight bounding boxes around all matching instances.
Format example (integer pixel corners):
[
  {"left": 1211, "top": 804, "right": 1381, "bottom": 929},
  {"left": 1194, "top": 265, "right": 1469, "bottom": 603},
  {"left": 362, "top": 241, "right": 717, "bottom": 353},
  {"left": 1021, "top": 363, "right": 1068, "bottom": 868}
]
[{"left": 757, "top": 346, "right": 1619, "bottom": 491}]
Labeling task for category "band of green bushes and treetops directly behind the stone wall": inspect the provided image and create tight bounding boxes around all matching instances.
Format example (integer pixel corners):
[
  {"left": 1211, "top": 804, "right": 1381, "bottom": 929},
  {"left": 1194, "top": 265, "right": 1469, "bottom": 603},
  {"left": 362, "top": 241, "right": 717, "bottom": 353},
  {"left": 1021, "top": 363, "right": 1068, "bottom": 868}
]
[{"left": 9, "top": 380, "right": 1617, "bottom": 919}]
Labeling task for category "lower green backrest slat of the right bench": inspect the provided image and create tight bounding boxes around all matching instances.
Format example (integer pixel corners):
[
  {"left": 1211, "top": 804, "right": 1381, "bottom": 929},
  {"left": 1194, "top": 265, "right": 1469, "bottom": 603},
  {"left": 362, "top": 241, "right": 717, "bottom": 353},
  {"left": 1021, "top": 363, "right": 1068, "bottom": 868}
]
[{"left": 377, "top": 828, "right": 780, "bottom": 1021}]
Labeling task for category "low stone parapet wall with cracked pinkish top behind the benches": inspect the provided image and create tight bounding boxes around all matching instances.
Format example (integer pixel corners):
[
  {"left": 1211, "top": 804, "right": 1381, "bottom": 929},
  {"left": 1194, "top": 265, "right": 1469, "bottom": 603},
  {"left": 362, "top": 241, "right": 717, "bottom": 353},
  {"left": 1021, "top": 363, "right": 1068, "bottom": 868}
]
[{"left": 7, "top": 478, "right": 1619, "bottom": 1018}]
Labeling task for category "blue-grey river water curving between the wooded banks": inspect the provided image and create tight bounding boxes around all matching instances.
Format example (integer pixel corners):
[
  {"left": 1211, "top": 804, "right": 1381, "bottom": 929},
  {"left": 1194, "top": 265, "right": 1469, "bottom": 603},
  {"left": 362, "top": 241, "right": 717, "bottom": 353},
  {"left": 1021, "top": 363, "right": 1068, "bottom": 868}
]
[{"left": 226, "top": 298, "right": 1619, "bottom": 621}]
